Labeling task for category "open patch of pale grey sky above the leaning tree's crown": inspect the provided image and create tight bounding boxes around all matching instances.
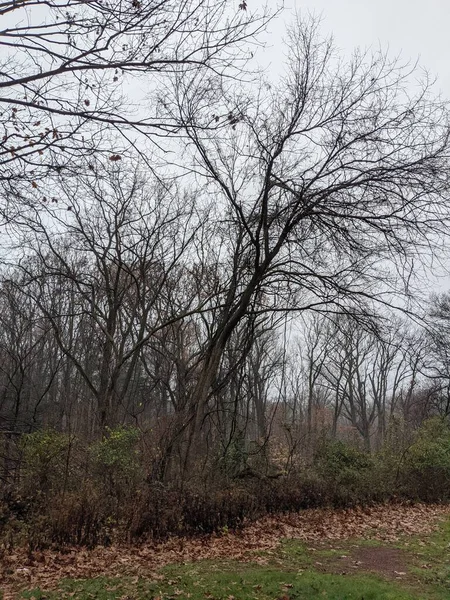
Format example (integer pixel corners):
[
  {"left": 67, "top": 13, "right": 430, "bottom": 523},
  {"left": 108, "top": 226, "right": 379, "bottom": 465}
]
[{"left": 264, "top": 0, "right": 450, "bottom": 98}]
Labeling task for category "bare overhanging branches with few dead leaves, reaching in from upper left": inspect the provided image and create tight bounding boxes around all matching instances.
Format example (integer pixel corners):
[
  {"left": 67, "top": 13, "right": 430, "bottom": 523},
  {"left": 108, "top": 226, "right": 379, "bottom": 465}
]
[{"left": 0, "top": 0, "right": 276, "bottom": 204}]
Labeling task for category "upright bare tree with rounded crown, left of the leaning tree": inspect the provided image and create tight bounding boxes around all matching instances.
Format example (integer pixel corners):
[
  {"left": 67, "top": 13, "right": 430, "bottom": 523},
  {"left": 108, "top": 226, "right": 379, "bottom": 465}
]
[{"left": 12, "top": 169, "right": 205, "bottom": 430}]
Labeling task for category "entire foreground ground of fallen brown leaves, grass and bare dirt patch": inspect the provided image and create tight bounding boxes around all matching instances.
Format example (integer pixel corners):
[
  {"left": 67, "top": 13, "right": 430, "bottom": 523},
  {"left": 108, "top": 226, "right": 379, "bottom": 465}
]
[{"left": 0, "top": 505, "right": 450, "bottom": 600}]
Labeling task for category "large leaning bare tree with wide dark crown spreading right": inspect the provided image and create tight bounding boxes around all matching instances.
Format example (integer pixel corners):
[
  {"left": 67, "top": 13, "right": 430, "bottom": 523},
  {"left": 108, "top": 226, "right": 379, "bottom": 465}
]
[{"left": 164, "top": 15, "right": 449, "bottom": 450}]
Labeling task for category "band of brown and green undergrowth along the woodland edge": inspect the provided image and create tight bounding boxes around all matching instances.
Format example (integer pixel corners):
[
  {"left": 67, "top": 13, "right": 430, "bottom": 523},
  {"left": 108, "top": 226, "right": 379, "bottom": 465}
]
[{"left": 4, "top": 419, "right": 450, "bottom": 549}]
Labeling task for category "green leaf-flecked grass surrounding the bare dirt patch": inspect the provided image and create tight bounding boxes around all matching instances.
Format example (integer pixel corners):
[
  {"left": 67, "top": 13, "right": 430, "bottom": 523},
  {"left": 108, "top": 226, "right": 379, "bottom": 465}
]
[{"left": 12, "top": 520, "right": 450, "bottom": 600}]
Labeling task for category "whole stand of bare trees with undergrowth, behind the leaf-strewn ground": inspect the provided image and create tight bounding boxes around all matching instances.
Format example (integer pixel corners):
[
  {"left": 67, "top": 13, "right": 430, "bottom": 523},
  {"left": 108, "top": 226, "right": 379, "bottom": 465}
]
[{"left": 0, "top": 0, "right": 450, "bottom": 556}]
